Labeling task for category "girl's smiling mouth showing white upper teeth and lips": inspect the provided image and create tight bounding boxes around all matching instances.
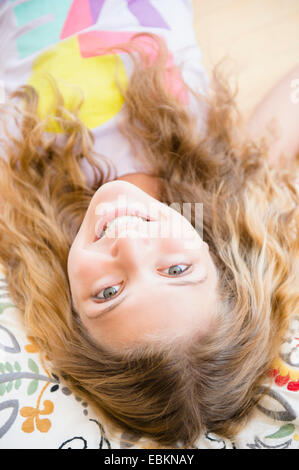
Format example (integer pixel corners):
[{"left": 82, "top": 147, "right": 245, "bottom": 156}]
[{"left": 94, "top": 208, "right": 154, "bottom": 241}]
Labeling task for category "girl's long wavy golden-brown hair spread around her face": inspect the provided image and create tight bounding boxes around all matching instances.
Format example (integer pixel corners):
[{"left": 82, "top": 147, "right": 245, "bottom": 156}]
[{"left": 0, "top": 35, "right": 299, "bottom": 447}]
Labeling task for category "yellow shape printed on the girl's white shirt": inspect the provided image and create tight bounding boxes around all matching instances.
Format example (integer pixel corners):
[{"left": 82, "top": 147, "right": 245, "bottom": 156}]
[{"left": 28, "top": 37, "right": 127, "bottom": 133}]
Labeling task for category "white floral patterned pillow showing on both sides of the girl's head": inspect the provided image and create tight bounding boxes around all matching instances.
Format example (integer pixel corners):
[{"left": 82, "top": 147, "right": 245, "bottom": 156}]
[{"left": 0, "top": 262, "right": 299, "bottom": 449}]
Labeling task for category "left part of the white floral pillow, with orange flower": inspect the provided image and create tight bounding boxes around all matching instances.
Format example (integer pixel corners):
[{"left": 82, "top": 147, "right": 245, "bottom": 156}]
[{"left": 0, "top": 264, "right": 119, "bottom": 449}]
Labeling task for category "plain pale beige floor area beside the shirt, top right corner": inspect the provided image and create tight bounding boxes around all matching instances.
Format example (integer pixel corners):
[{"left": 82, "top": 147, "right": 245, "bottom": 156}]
[{"left": 193, "top": 0, "right": 299, "bottom": 116}]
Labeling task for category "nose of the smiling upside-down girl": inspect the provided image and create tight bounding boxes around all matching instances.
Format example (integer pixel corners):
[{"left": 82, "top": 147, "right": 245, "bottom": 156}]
[{"left": 110, "top": 232, "right": 154, "bottom": 268}]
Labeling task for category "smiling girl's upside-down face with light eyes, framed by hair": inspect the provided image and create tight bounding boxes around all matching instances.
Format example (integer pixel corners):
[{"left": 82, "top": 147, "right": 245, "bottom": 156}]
[{"left": 68, "top": 181, "right": 217, "bottom": 349}]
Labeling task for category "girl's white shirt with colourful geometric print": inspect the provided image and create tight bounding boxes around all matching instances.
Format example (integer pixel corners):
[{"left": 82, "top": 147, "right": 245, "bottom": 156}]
[{"left": 0, "top": 0, "right": 208, "bottom": 184}]
